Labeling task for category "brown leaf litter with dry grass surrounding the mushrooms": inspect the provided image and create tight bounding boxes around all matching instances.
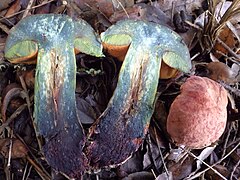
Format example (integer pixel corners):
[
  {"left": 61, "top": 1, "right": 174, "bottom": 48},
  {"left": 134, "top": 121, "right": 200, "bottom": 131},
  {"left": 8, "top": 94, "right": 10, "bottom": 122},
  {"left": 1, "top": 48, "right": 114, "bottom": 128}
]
[{"left": 0, "top": 0, "right": 240, "bottom": 179}]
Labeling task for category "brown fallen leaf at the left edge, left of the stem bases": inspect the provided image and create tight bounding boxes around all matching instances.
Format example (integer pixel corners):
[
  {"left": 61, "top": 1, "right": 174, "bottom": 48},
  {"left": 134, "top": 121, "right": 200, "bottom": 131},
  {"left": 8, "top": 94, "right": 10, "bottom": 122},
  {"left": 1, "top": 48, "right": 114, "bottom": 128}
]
[{"left": 0, "top": 138, "right": 28, "bottom": 159}]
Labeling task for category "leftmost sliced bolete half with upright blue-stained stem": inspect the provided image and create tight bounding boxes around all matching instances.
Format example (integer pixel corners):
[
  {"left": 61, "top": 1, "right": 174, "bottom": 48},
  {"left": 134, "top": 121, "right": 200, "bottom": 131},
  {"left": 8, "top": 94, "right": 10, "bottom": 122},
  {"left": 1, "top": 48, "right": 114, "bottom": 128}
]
[{"left": 5, "top": 14, "right": 103, "bottom": 178}]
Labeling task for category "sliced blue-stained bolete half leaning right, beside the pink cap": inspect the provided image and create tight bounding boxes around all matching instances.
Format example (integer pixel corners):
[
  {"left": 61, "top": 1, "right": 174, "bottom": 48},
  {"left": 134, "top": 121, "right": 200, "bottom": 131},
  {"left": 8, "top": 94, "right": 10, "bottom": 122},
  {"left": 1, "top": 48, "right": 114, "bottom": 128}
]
[{"left": 86, "top": 20, "right": 191, "bottom": 168}]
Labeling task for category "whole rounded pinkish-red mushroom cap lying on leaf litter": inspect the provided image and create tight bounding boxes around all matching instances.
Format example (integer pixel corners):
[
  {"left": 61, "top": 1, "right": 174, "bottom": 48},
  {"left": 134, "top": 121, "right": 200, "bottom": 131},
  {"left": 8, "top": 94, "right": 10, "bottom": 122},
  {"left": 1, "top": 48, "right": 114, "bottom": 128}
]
[{"left": 167, "top": 76, "right": 228, "bottom": 149}]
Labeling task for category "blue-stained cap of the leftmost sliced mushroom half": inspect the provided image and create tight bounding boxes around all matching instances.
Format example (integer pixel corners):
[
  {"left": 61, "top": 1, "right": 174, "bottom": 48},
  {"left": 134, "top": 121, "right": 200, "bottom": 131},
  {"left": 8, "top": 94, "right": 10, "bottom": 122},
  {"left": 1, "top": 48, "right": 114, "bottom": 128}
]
[{"left": 4, "top": 14, "right": 103, "bottom": 64}]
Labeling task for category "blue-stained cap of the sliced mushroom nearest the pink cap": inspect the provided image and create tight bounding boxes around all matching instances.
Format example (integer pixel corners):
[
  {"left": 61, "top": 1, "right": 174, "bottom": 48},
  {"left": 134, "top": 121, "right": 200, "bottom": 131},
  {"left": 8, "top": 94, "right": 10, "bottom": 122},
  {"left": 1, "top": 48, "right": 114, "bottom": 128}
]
[{"left": 101, "top": 20, "right": 191, "bottom": 79}]
